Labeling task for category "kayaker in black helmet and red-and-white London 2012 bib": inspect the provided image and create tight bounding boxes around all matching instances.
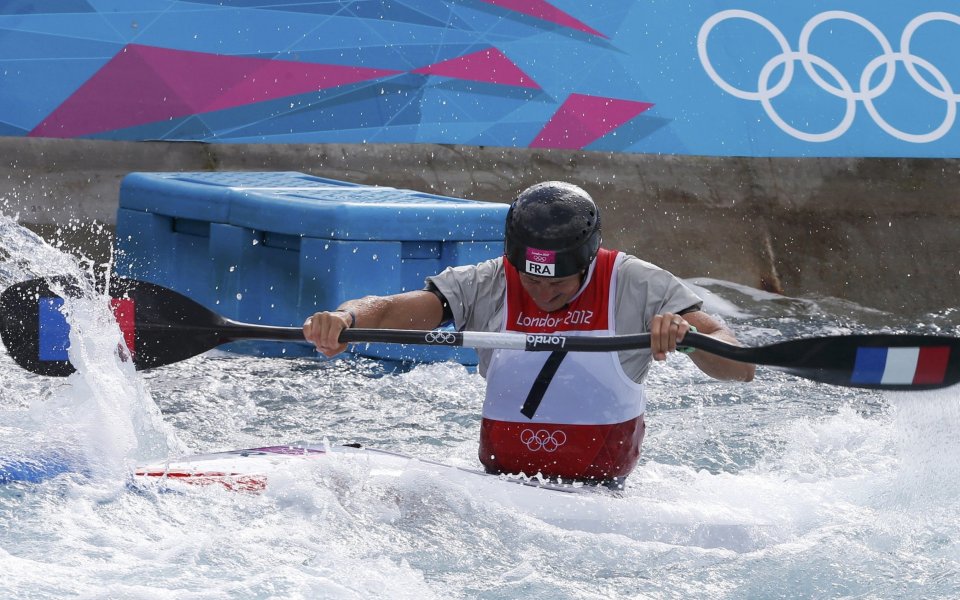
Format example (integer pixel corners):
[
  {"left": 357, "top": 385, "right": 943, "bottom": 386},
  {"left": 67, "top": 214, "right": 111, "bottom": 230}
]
[{"left": 303, "top": 181, "right": 755, "bottom": 486}]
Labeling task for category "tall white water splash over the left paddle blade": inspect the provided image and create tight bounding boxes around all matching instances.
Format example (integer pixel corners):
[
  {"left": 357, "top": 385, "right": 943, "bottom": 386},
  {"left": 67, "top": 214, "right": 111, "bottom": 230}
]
[{"left": 0, "top": 214, "right": 185, "bottom": 482}]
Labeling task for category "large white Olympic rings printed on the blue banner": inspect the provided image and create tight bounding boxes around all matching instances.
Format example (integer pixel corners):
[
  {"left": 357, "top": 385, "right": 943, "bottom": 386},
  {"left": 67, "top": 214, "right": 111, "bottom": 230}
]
[{"left": 697, "top": 9, "right": 960, "bottom": 144}]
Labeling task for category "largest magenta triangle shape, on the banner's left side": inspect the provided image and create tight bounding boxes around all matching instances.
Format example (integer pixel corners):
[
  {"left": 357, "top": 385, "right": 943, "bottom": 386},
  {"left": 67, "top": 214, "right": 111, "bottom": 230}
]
[{"left": 29, "top": 44, "right": 402, "bottom": 138}]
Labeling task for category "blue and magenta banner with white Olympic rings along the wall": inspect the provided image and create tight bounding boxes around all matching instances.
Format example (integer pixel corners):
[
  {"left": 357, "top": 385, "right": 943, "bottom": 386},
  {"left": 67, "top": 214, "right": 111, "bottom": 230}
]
[{"left": 0, "top": 0, "right": 960, "bottom": 157}]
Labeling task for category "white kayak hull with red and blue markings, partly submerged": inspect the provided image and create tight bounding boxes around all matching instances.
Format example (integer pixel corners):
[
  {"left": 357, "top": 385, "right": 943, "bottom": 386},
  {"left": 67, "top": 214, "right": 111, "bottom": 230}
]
[{"left": 0, "top": 445, "right": 777, "bottom": 551}]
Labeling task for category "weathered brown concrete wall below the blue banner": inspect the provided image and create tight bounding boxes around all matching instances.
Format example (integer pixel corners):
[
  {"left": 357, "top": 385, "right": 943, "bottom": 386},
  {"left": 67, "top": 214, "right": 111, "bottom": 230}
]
[{"left": 0, "top": 138, "right": 960, "bottom": 314}]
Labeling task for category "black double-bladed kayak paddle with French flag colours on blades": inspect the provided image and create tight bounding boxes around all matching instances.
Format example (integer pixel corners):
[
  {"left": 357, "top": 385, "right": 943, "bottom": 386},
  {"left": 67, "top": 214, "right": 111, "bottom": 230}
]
[{"left": 0, "top": 277, "right": 960, "bottom": 390}]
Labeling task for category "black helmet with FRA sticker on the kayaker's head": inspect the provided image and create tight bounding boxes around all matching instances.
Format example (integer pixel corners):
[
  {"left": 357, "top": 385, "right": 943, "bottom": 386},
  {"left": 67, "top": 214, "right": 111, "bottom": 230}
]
[{"left": 504, "top": 181, "right": 600, "bottom": 277}]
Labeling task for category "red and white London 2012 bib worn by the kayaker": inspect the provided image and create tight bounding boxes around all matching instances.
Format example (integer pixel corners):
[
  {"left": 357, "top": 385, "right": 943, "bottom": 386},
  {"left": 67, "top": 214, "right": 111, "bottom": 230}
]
[{"left": 479, "top": 249, "right": 645, "bottom": 481}]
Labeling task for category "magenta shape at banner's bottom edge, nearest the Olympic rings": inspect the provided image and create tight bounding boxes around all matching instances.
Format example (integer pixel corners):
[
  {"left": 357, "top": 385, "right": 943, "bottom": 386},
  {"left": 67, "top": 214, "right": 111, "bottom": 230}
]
[{"left": 530, "top": 94, "right": 653, "bottom": 150}]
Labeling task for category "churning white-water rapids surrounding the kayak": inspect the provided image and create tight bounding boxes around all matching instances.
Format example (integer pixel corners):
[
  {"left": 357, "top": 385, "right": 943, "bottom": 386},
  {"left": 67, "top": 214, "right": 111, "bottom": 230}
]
[{"left": 0, "top": 214, "right": 960, "bottom": 599}]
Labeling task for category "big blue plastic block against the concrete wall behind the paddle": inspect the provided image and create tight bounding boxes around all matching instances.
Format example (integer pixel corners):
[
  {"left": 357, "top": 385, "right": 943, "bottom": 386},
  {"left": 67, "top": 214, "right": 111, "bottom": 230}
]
[{"left": 115, "top": 172, "right": 507, "bottom": 364}]
